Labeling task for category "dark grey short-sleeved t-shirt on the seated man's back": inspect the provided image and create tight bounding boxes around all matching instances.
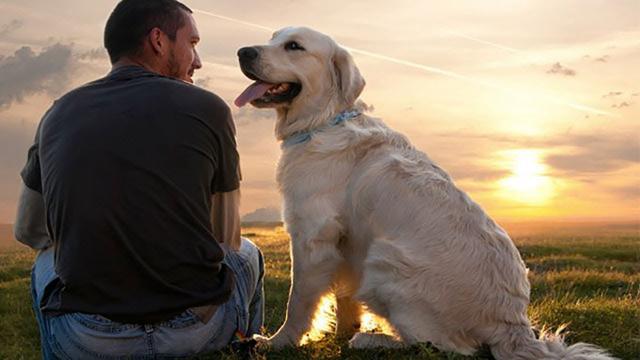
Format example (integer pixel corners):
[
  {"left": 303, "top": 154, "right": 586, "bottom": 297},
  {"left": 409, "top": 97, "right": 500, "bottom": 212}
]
[{"left": 22, "top": 66, "right": 240, "bottom": 322}]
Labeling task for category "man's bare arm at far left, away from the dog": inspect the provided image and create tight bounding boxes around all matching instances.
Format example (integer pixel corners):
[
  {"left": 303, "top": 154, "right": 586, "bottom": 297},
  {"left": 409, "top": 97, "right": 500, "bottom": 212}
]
[{"left": 13, "top": 183, "right": 52, "bottom": 250}]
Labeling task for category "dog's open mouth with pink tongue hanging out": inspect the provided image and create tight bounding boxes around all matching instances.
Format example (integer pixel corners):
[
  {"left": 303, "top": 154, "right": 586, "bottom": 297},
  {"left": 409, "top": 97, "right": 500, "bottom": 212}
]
[{"left": 234, "top": 80, "right": 302, "bottom": 107}]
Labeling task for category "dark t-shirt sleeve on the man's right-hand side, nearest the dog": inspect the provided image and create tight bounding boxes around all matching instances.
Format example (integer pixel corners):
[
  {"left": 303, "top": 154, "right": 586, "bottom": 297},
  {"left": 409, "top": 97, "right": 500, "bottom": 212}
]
[{"left": 211, "top": 108, "right": 242, "bottom": 193}]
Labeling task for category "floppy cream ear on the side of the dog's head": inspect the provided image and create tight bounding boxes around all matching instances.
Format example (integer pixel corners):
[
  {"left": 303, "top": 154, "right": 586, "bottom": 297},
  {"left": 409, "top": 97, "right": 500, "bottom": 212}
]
[{"left": 333, "top": 46, "right": 365, "bottom": 106}]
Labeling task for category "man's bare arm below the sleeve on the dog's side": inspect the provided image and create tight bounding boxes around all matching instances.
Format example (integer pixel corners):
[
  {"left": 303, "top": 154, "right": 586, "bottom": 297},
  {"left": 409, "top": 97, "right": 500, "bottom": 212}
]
[{"left": 211, "top": 189, "right": 240, "bottom": 251}]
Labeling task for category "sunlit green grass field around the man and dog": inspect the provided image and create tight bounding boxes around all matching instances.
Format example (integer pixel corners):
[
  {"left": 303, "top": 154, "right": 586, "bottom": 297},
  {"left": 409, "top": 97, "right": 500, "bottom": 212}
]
[{"left": 0, "top": 224, "right": 640, "bottom": 360}]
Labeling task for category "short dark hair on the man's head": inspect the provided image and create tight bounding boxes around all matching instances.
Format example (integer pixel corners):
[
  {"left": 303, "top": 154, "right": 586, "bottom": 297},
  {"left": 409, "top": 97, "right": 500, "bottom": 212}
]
[{"left": 104, "top": 0, "right": 193, "bottom": 64}]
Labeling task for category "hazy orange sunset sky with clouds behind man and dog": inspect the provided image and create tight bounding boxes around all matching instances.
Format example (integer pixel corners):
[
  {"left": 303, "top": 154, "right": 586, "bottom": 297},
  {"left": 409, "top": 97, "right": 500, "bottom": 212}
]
[{"left": 0, "top": 0, "right": 640, "bottom": 223}]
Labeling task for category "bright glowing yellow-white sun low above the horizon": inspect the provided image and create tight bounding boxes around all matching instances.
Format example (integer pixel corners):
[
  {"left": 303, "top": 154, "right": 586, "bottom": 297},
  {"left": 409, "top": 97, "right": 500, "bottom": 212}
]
[{"left": 498, "top": 149, "right": 555, "bottom": 206}]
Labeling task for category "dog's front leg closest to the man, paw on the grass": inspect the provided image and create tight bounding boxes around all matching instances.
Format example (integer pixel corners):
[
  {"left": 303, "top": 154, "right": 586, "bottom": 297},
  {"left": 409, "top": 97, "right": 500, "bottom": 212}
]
[{"left": 268, "top": 219, "right": 342, "bottom": 348}]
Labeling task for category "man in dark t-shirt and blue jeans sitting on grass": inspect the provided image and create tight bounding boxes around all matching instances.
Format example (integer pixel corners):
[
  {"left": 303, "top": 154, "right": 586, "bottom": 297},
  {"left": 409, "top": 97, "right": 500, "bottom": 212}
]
[{"left": 15, "top": 0, "right": 263, "bottom": 359}]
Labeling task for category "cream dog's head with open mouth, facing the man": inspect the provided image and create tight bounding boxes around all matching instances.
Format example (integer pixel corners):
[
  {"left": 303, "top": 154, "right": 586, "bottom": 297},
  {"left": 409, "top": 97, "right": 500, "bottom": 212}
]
[{"left": 236, "top": 27, "right": 365, "bottom": 134}]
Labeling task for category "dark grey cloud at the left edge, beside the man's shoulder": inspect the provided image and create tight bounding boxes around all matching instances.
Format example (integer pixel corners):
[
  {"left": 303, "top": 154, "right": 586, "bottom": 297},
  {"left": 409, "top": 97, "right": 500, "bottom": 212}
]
[{"left": 0, "top": 44, "right": 74, "bottom": 110}]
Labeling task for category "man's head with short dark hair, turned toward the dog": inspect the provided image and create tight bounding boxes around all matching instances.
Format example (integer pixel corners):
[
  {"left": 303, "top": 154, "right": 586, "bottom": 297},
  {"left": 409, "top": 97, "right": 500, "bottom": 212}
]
[{"left": 104, "top": 0, "right": 202, "bottom": 82}]
